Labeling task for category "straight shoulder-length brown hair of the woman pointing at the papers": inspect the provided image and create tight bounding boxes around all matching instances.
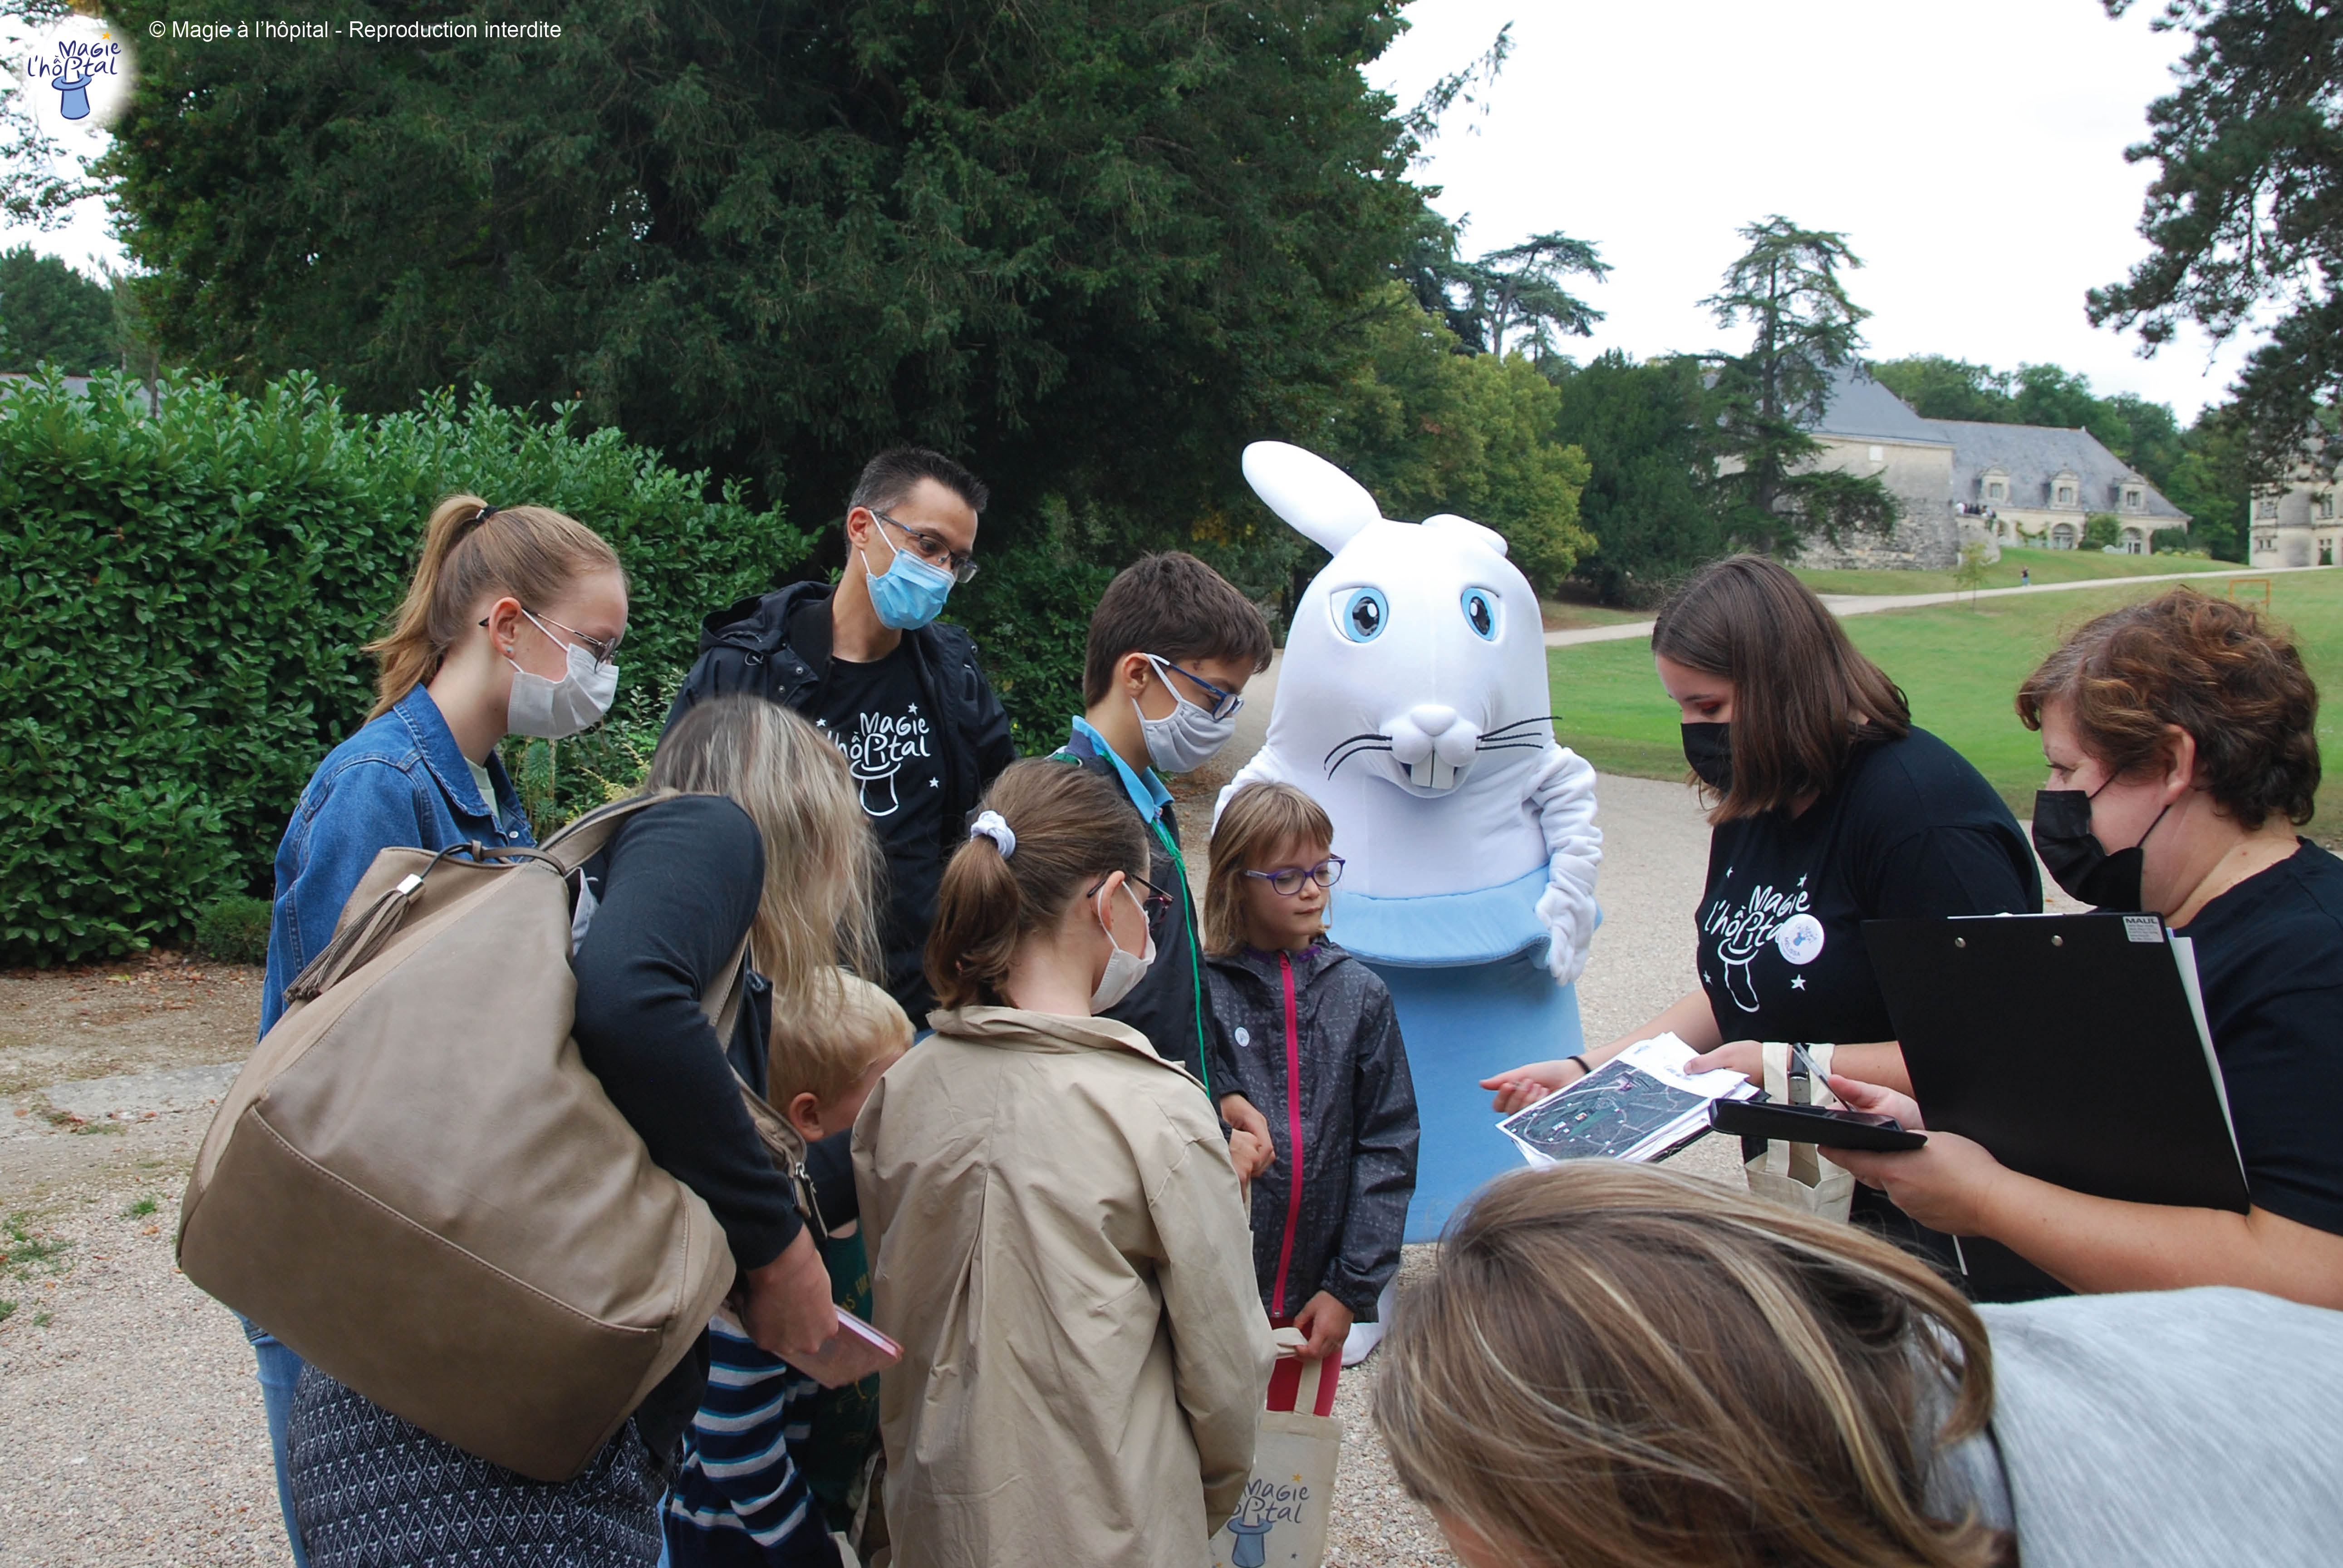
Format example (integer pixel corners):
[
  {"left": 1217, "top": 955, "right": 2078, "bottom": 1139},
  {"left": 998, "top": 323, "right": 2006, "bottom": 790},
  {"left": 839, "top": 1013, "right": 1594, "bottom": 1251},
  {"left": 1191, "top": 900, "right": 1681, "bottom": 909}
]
[{"left": 1652, "top": 555, "right": 1912, "bottom": 823}]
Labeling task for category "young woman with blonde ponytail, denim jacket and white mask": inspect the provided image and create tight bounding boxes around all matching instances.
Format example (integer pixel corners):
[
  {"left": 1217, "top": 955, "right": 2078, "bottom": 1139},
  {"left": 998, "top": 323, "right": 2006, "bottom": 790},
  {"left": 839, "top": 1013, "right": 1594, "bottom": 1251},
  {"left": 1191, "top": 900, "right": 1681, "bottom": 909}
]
[{"left": 246, "top": 495, "right": 626, "bottom": 1568}]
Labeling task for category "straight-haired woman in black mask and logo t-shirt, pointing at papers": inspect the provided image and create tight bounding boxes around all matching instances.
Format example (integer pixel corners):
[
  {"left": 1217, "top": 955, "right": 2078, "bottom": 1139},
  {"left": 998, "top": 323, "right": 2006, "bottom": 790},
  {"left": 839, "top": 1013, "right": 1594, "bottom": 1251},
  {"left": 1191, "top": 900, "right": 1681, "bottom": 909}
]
[{"left": 1483, "top": 555, "right": 2041, "bottom": 1266}]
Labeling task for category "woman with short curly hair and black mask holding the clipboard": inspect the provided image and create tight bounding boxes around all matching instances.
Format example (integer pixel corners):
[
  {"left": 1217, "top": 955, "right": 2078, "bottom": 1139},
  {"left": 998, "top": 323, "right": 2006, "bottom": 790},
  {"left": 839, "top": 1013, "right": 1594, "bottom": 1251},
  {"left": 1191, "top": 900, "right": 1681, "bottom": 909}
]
[{"left": 1832, "top": 588, "right": 2343, "bottom": 1308}]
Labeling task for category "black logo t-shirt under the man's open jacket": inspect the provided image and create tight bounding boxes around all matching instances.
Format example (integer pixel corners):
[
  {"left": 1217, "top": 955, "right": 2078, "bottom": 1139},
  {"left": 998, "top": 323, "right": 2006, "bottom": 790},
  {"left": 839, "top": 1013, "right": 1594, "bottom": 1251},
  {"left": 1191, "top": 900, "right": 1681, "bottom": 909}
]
[{"left": 806, "top": 645, "right": 944, "bottom": 1027}]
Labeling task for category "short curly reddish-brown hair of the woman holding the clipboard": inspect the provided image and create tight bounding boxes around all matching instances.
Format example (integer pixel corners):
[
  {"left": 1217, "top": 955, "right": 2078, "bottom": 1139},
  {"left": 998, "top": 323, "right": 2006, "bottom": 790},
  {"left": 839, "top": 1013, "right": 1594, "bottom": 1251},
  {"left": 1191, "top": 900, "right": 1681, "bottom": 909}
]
[{"left": 2017, "top": 588, "right": 2319, "bottom": 830}]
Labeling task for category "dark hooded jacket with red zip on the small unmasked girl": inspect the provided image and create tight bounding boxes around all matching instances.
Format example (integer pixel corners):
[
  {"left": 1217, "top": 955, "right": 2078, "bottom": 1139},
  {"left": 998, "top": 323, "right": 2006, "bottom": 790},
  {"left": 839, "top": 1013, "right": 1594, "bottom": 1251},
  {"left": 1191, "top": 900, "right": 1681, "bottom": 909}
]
[{"left": 1204, "top": 942, "right": 1418, "bottom": 1322}]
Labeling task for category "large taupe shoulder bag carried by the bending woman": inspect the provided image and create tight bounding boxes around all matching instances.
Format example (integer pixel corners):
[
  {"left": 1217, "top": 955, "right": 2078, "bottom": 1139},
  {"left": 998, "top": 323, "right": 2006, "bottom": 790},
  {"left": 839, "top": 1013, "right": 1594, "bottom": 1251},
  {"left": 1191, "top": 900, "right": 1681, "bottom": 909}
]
[{"left": 178, "top": 797, "right": 741, "bottom": 1481}]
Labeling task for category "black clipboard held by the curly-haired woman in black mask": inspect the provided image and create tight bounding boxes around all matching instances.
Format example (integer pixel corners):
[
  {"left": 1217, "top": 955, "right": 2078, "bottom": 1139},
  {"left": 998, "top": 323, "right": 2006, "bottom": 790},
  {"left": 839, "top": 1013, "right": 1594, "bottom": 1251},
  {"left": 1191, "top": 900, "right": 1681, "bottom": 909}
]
[{"left": 1863, "top": 914, "right": 2249, "bottom": 1298}]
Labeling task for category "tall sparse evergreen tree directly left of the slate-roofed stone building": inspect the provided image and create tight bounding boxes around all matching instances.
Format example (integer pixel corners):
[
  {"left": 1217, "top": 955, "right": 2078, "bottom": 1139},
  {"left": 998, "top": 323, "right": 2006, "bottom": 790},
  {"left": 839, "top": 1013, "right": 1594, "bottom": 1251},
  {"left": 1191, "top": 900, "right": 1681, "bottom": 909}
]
[{"left": 1701, "top": 213, "right": 1898, "bottom": 553}]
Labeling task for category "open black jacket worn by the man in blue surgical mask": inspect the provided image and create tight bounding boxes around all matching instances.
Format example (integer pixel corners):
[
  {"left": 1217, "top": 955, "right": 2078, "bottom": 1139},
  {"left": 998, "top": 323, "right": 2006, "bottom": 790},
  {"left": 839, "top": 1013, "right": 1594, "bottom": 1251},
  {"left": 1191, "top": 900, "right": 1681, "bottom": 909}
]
[{"left": 668, "top": 583, "right": 1017, "bottom": 1022}]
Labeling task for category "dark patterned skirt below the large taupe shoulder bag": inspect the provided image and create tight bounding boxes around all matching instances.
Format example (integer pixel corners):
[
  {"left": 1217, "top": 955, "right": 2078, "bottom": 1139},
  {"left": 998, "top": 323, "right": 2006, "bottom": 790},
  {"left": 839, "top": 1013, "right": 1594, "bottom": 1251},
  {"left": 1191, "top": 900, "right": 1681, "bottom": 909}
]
[{"left": 286, "top": 1367, "right": 663, "bottom": 1568}]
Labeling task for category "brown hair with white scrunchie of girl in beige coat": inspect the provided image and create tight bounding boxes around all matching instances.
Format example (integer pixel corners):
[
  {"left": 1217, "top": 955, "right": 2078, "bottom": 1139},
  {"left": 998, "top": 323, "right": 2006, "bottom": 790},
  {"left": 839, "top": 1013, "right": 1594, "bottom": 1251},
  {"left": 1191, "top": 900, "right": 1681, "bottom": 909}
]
[{"left": 928, "top": 757, "right": 1148, "bottom": 1008}]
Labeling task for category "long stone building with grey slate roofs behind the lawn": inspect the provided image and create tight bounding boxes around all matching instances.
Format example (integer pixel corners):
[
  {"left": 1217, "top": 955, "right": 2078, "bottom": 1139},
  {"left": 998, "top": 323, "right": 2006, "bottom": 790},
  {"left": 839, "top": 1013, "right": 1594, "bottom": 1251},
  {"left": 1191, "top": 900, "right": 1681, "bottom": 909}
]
[{"left": 1799, "top": 363, "right": 2188, "bottom": 569}]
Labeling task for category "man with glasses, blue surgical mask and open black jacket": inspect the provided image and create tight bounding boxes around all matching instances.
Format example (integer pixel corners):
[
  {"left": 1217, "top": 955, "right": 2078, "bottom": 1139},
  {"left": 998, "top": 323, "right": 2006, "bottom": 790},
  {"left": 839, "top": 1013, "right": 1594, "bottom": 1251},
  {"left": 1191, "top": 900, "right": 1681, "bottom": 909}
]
[{"left": 668, "top": 448, "right": 1017, "bottom": 1022}]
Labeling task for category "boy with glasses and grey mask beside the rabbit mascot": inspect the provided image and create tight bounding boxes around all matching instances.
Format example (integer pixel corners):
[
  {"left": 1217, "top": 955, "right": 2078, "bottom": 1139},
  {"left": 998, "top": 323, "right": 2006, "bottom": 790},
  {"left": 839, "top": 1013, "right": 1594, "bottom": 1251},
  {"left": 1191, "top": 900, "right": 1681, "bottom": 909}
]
[{"left": 1057, "top": 551, "right": 1270, "bottom": 1087}]
